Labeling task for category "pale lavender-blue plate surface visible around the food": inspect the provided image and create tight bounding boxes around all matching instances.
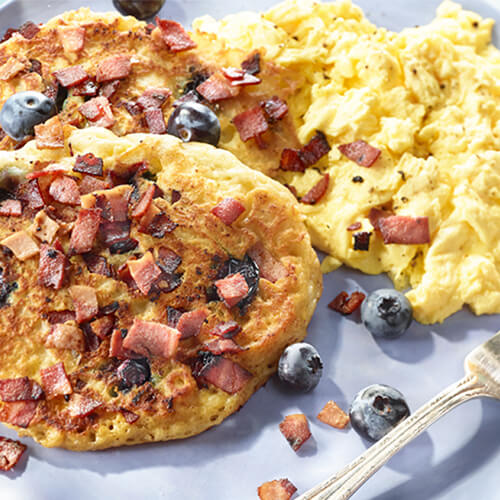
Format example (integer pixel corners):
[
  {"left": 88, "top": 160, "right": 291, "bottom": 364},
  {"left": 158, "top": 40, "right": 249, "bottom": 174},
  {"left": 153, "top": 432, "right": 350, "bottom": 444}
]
[{"left": 0, "top": 0, "right": 500, "bottom": 500}]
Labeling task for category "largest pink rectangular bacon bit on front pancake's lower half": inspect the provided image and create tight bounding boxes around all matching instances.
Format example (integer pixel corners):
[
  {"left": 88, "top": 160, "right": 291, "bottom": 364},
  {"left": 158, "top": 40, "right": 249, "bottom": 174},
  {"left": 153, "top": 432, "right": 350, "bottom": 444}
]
[{"left": 123, "top": 318, "right": 181, "bottom": 359}]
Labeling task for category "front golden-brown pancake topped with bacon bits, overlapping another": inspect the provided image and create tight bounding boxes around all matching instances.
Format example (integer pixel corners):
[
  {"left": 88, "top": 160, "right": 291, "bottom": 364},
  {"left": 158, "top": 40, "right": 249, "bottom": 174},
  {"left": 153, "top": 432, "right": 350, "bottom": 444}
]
[{"left": 0, "top": 125, "right": 321, "bottom": 450}]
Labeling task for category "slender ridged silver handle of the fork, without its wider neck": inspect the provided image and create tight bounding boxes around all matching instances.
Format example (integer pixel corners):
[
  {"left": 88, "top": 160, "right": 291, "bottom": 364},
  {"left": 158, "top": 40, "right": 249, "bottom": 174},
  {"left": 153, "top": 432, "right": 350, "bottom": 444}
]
[{"left": 297, "top": 374, "right": 488, "bottom": 500}]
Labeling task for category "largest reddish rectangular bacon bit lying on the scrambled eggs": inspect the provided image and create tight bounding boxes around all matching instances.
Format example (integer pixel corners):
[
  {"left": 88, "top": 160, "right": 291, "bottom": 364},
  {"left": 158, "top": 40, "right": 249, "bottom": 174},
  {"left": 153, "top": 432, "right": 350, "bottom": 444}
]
[{"left": 378, "top": 215, "right": 431, "bottom": 245}]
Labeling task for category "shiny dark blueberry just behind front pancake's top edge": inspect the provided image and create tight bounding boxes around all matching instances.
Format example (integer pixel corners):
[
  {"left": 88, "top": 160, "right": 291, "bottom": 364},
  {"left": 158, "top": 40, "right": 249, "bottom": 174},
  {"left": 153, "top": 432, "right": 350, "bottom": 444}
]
[{"left": 167, "top": 101, "right": 220, "bottom": 146}]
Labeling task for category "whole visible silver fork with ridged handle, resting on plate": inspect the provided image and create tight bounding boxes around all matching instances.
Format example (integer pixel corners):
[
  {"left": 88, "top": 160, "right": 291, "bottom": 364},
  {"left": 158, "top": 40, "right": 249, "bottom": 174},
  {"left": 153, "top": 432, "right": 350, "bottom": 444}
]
[{"left": 297, "top": 332, "right": 500, "bottom": 500}]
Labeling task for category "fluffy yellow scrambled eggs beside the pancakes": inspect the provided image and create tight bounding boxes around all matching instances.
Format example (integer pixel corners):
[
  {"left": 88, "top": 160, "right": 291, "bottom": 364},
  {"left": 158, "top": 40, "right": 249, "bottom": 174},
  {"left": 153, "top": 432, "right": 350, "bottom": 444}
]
[{"left": 194, "top": 0, "right": 500, "bottom": 323}]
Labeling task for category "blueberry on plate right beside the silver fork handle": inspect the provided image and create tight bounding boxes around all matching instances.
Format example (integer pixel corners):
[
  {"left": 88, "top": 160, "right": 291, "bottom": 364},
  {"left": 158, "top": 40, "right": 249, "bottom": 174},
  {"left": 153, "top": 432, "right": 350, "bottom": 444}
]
[{"left": 349, "top": 384, "right": 410, "bottom": 442}]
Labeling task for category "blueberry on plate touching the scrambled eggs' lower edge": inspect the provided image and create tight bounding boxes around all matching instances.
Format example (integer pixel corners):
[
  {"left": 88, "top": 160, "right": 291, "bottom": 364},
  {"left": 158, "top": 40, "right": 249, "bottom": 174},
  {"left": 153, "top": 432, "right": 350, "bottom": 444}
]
[{"left": 361, "top": 288, "right": 413, "bottom": 339}]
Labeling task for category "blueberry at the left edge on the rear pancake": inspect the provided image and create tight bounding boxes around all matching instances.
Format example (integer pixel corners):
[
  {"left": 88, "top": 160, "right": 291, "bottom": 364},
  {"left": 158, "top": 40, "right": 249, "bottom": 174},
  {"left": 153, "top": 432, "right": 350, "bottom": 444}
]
[{"left": 0, "top": 90, "right": 56, "bottom": 141}]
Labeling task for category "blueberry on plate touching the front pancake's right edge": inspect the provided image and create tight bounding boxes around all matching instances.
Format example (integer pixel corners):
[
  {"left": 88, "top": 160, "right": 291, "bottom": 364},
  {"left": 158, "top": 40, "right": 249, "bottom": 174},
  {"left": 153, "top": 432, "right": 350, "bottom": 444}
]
[{"left": 278, "top": 342, "right": 323, "bottom": 392}]
